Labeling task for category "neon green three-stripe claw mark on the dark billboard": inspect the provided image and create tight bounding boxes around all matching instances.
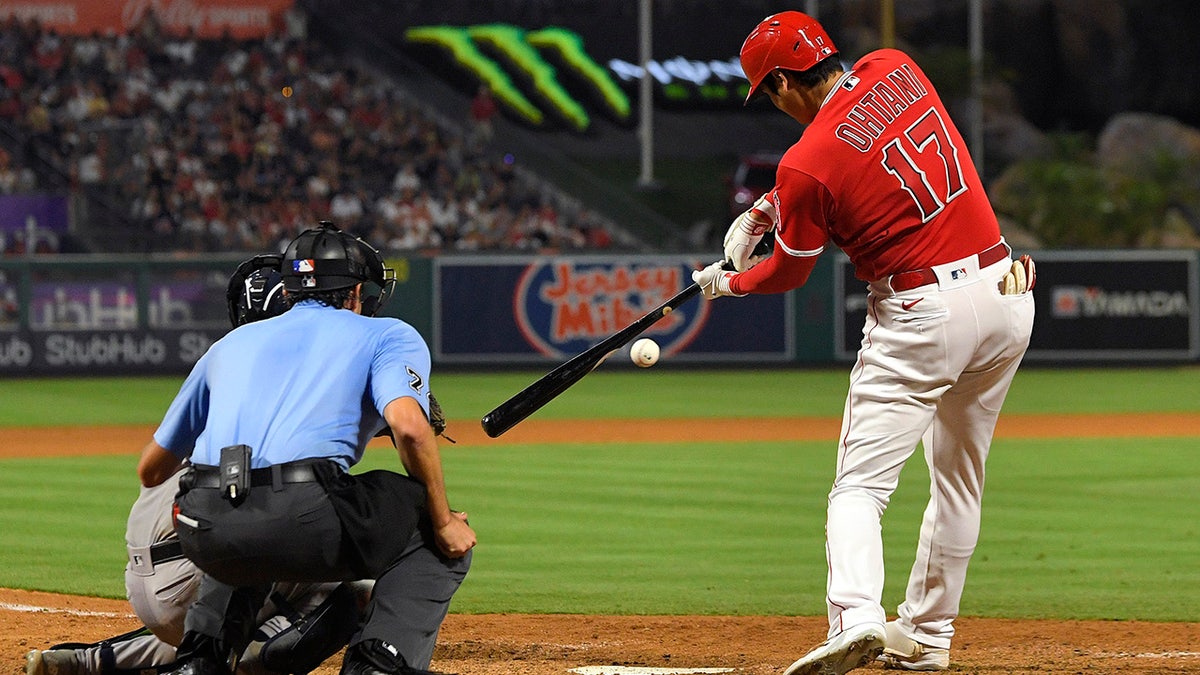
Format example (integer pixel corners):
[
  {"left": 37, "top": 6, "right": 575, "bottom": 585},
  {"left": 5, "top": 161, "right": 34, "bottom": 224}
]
[{"left": 404, "top": 24, "right": 630, "bottom": 131}]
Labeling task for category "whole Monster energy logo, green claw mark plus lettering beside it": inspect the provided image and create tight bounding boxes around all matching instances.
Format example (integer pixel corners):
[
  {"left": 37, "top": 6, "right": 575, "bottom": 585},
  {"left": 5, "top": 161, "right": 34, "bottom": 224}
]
[{"left": 404, "top": 24, "right": 746, "bottom": 132}]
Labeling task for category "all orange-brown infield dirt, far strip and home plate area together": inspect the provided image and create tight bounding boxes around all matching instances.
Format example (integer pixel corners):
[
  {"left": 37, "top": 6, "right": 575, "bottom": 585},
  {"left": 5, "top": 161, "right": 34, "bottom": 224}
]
[{"left": 0, "top": 414, "right": 1200, "bottom": 675}]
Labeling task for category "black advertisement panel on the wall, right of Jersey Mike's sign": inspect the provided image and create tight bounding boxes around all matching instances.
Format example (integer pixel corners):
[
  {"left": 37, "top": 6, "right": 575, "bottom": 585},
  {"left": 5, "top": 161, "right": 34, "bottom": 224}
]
[{"left": 835, "top": 251, "right": 1200, "bottom": 363}]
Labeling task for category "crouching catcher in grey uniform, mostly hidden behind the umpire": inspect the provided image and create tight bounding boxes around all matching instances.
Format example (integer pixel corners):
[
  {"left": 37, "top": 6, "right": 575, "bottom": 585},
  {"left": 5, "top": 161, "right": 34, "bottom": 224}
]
[{"left": 25, "top": 256, "right": 371, "bottom": 675}]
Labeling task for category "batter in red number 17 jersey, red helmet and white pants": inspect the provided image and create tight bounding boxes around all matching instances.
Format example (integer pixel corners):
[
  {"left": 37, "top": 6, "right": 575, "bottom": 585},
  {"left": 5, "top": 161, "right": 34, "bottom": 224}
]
[{"left": 692, "top": 12, "right": 1034, "bottom": 675}]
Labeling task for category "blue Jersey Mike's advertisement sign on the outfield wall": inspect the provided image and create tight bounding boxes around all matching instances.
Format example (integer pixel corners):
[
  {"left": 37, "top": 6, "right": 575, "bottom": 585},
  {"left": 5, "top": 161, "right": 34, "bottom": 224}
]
[{"left": 431, "top": 256, "right": 792, "bottom": 365}]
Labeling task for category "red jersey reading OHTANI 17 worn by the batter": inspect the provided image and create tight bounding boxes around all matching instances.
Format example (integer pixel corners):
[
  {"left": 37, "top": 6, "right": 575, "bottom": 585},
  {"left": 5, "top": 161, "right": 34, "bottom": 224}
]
[{"left": 731, "top": 49, "right": 1000, "bottom": 293}]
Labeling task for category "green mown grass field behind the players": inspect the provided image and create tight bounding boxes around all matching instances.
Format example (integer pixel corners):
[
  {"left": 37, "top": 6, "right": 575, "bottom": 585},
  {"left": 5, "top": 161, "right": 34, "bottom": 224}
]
[{"left": 0, "top": 364, "right": 1200, "bottom": 621}]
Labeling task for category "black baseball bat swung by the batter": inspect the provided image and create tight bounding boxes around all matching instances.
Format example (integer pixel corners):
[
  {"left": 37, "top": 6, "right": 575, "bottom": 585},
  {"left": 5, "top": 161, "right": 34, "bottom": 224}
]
[{"left": 480, "top": 275, "right": 700, "bottom": 438}]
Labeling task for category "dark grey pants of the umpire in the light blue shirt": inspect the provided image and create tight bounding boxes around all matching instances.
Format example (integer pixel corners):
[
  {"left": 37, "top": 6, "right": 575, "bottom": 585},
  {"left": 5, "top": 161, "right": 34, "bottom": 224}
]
[{"left": 176, "top": 470, "right": 470, "bottom": 669}]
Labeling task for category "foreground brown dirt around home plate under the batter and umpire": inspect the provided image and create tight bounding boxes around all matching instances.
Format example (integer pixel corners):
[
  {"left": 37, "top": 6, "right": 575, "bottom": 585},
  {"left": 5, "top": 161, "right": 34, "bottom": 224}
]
[{"left": 9, "top": 590, "right": 1200, "bottom": 675}]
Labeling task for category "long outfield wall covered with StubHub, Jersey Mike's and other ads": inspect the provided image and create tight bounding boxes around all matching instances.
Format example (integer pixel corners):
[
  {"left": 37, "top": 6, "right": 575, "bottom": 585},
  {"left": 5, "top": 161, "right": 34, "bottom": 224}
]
[{"left": 0, "top": 251, "right": 1200, "bottom": 376}]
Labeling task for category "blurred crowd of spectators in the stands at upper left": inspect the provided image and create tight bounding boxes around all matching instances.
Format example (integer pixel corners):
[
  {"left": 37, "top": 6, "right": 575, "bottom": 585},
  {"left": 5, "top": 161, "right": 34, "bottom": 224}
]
[{"left": 0, "top": 13, "right": 614, "bottom": 252}]
